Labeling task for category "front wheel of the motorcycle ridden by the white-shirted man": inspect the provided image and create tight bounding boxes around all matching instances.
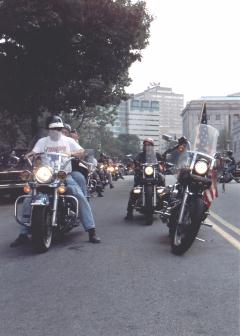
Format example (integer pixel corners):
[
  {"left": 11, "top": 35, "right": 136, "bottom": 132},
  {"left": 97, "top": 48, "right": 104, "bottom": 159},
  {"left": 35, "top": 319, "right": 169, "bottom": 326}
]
[{"left": 32, "top": 206, "right": 53, "bottom": 252}]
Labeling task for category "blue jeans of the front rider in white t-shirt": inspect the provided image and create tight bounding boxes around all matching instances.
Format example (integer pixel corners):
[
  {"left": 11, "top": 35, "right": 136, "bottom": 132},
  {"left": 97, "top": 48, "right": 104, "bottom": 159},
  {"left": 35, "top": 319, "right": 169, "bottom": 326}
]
[{"left": 20, "top": 175, "right": 95, "bottom": 234}]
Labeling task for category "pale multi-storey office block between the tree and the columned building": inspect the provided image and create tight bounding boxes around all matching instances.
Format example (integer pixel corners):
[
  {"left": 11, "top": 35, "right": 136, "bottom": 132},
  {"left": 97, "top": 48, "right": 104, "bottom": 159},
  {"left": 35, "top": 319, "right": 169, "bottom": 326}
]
[{"left": 112, "top": 85, "right": 184, "bottom": 151}]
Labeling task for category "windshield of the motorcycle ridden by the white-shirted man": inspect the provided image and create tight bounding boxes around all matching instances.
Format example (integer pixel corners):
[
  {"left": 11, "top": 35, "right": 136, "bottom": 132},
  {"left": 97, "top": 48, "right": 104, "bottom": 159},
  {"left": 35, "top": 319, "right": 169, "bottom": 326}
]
[{"left": 34, "top": 153, "right": 71, "bottom": 172}]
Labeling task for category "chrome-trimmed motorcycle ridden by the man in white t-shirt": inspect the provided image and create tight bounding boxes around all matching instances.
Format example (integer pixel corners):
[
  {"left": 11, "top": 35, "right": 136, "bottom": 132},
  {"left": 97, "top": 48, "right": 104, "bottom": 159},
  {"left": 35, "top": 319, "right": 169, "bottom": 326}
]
[{"left": 15, "top": 153, "right": 79, "bottom": 252}]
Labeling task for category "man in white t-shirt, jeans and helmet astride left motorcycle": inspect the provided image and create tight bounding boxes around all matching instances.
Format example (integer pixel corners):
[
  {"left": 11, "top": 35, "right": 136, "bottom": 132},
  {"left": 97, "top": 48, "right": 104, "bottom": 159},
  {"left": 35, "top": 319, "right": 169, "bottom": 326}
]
[{"left": 11, "top": 116, "right": 100, "bottom": 247}]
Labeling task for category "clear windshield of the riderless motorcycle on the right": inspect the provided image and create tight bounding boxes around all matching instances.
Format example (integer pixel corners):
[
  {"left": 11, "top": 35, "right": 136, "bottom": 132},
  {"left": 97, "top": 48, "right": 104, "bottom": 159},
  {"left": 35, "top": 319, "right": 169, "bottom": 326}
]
[{"left": 192, "top": 124, "right": 219, "bottom": 156}]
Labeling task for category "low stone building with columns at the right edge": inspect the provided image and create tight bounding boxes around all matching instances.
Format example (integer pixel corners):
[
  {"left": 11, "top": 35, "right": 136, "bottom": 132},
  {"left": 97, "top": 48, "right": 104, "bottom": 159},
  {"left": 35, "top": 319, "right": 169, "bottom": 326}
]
[{"left": 181, "top": 93, "right": 240, "bottom": 147}]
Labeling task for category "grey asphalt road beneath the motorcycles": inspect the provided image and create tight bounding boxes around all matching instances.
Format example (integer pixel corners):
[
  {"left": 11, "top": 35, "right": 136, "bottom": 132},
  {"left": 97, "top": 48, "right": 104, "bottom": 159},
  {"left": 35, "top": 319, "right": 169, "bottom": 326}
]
[{"left": 0, "top": 177, "right": 240, "bottom": 336}]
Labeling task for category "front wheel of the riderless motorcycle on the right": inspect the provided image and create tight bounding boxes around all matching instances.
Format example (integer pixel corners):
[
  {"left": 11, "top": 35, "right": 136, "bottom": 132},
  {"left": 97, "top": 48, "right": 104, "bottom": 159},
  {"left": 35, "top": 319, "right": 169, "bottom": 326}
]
[{"left": 170, "top": 198, "right": 205, "bottom": 255}]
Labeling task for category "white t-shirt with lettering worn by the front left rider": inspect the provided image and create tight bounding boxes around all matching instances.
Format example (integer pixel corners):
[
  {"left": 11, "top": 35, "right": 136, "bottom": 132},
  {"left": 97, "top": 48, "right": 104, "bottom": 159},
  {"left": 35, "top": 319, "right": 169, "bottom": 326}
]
[{"left": 32, "top": 134, "right": 83, "bottom": 172}]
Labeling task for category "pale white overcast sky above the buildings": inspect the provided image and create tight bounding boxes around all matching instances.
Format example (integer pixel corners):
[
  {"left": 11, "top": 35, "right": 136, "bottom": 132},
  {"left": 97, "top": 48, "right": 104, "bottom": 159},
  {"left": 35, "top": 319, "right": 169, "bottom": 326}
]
[{"left": 127, "top": 0, "right": 240, "bottom": 103}]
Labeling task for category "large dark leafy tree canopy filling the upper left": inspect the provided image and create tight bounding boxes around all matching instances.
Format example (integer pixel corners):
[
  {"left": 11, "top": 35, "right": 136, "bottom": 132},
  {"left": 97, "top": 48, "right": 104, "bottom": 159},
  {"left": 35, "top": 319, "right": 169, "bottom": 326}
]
[{"left": 0, "top": 0, "right": 152, "bottom": 142}]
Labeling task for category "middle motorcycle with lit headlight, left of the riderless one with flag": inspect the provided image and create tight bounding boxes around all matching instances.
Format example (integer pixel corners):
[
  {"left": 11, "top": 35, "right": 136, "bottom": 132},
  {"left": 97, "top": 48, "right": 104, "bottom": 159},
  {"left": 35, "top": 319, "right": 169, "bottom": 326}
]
[{"left": 132, "top": 146, "right": 165, "bottom": 225}]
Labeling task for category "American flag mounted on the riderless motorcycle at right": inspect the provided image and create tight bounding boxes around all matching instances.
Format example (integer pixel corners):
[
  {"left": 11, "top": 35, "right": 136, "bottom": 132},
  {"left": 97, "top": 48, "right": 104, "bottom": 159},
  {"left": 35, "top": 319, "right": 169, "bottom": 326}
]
[{"left": 199, "top": 102, "right": 218, "bottom": 208}]
